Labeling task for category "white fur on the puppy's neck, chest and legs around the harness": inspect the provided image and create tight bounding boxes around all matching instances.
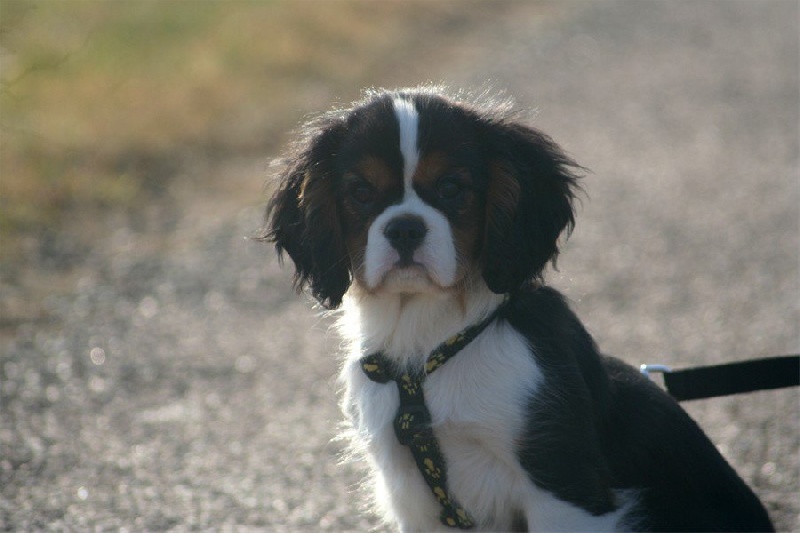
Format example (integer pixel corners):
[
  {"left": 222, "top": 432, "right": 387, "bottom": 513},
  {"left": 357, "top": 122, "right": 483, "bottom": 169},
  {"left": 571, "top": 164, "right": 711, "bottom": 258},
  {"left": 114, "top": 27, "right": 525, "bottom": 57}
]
[{"left": 340, "top": 286, "right": 632, "bottom": 531}]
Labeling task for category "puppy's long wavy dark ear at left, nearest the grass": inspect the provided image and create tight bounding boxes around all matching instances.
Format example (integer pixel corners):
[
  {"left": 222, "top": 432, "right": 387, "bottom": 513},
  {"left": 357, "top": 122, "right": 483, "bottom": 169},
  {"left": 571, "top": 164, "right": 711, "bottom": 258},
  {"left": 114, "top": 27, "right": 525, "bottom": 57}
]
[{"left": 262, "top": 122, "right": 351, "bottom": 309}]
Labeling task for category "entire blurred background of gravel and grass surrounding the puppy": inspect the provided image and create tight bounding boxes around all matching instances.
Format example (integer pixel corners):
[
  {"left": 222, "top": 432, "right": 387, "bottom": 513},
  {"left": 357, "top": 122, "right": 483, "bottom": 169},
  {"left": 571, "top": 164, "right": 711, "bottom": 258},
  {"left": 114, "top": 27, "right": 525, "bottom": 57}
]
[{"left": 0, "top": 0, "right": 800, "bottom": 531}]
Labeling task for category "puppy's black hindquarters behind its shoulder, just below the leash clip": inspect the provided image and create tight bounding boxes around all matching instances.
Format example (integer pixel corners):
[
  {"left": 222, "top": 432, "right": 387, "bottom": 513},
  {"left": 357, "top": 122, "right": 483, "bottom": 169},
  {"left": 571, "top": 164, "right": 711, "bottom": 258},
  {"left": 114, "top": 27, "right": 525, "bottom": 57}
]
[{"left": 604, "top": 357, "right": 773, "bottom": 531}]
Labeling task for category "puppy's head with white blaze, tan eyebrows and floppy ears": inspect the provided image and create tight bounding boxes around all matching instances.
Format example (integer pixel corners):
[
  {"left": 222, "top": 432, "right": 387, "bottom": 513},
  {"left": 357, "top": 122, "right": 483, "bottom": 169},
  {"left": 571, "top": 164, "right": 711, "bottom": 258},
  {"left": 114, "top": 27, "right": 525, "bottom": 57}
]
[{"left": 265, "top": 89, "right": 579, "bottom": 308}]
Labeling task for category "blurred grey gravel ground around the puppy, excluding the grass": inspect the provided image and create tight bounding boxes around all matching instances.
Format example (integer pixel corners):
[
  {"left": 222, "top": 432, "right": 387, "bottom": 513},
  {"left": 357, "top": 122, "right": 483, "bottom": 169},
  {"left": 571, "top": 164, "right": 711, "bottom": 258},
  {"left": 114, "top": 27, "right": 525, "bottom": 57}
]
[{"left": 0, "top": 1, "right": 800, "bottom": 531}]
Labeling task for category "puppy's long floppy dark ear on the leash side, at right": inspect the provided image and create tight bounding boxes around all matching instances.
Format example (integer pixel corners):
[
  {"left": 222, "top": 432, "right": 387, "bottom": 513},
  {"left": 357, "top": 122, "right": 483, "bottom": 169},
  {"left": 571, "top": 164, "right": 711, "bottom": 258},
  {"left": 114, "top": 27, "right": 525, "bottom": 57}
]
[{"left": 483, "top": 121, "right": 580, "bottom": 294}]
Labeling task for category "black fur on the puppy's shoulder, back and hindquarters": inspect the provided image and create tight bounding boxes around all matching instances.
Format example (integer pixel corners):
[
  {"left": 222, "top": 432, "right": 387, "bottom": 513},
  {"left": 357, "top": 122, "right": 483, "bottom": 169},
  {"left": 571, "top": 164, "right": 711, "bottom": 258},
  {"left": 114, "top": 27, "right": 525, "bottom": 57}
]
[{"left": 503, "top": 287, "right": 773, "bottom": 531}]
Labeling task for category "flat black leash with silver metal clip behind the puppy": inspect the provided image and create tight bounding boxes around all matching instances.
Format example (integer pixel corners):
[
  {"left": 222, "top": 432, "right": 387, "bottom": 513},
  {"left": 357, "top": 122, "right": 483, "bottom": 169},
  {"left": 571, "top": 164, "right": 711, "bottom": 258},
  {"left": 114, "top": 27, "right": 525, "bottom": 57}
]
[{"left": 639, "top": 355, "right": 800, "bottom": 402}]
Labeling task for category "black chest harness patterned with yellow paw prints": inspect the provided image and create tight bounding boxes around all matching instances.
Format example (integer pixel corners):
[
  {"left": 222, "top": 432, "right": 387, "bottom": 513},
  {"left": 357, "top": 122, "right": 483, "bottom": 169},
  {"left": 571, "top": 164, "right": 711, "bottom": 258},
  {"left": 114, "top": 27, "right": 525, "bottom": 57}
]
[{"left": 361, "top": 306, "right": 502, "bottom": 529}]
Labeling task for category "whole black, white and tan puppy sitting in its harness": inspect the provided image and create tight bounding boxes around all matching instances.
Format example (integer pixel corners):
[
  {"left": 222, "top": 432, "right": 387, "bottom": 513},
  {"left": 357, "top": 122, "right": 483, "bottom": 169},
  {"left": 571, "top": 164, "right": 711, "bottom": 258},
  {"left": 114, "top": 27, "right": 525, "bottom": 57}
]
[{"left": 263, "top": 87, "right": 772, "bottom": 531}]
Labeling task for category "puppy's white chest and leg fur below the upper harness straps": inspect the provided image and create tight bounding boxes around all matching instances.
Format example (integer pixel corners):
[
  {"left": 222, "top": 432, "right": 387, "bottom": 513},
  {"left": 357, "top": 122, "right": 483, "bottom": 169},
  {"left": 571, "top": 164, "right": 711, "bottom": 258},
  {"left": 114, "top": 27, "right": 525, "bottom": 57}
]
[{"left": 341, "top": 306, "right": 632, "bottom": 531}]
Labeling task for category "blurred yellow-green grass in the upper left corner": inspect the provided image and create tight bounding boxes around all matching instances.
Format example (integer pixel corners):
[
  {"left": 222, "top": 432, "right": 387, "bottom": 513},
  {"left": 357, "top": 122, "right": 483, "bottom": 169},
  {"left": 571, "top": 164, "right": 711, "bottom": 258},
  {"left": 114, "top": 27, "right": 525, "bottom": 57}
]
[{"left": 0, "top": 0, "right": 482, "bottom": 246}]
